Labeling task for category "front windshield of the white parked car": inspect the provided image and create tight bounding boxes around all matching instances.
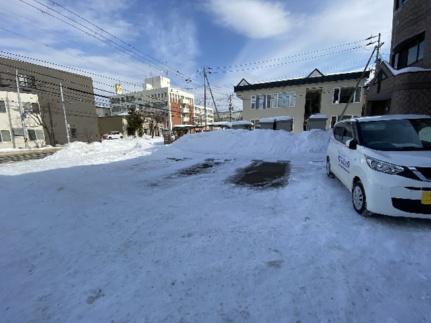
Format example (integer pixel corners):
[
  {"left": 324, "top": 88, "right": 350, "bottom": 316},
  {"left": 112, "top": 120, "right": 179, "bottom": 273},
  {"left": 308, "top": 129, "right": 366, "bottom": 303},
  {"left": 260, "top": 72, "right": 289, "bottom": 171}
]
[{"left": 358, "top": 119, "right": 431, "bottom": 151}]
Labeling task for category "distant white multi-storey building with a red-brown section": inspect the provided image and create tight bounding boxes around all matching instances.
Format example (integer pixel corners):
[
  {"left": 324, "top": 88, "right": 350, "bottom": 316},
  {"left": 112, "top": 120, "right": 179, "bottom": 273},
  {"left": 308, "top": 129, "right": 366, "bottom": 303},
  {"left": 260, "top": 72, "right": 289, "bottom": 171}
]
[{"left": 111, "top": 76, "right": 194, "bottom": 129}]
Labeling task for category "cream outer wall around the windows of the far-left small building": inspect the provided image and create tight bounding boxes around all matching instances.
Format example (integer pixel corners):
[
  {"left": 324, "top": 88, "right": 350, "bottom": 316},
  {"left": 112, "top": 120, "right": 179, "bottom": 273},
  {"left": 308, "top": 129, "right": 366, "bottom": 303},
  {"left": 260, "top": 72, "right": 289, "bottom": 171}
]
[{"left": 0, "top": 91, "right": 45, "bottom": 149}]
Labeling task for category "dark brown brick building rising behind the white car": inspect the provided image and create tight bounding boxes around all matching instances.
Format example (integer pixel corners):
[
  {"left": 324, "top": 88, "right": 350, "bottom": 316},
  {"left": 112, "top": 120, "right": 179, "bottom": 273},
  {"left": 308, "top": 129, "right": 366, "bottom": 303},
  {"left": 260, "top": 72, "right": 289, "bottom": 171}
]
[{"left": 366, "top": 0, "right": 431, "bottom": 115}]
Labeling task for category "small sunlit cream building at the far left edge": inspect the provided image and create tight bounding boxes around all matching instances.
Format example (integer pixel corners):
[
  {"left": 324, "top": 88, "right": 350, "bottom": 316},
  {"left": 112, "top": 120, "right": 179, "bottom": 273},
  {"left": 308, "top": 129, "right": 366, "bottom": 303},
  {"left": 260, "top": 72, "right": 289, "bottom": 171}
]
[{"left": 0, "top": 91, "right": 45, "bottom": 149}]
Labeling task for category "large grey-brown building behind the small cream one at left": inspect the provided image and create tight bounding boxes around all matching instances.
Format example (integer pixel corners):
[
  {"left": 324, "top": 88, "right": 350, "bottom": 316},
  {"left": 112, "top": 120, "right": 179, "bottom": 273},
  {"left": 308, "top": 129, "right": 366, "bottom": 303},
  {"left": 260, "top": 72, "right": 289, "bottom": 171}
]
[{"left": 0, "top": 58, "right": 99, "bottom": 145}]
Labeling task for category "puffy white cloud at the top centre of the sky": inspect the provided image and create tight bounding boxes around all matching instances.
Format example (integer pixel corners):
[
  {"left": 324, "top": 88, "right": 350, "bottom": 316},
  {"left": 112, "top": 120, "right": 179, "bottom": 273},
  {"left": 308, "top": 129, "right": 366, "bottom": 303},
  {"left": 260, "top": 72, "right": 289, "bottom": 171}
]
[{"left": 207, "top": 0, "right": 291, "bottom": 38}]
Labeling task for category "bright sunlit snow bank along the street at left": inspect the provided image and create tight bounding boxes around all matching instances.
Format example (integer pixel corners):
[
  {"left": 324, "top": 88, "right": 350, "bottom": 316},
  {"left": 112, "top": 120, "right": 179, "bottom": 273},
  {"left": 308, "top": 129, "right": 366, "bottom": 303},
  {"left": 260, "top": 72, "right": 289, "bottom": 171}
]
[{"left": 0, "top": 136, "right": 162, "bottom": 175}]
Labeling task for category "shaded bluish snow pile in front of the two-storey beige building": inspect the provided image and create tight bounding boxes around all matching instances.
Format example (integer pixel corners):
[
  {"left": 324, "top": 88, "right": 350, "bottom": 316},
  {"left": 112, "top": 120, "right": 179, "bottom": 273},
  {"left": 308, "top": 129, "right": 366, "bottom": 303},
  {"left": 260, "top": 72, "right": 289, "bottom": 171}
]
[{"left": 172, "top": 130, "right": 330, "bottom": 160}]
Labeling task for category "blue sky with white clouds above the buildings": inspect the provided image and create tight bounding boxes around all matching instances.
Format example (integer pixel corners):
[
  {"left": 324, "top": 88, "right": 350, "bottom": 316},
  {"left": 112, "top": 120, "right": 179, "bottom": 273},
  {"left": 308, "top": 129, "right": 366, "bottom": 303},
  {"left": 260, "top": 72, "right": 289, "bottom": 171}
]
[{"left": 0, "top": 0, "right": 392, "bottom": 109}]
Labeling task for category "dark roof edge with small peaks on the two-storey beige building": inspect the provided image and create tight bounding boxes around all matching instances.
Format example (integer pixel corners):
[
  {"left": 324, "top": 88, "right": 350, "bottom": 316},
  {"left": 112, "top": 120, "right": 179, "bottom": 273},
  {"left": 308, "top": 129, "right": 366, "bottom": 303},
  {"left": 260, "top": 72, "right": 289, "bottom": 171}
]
[{"left": 234, "top": 69, "right": 370, "bottom": 92}]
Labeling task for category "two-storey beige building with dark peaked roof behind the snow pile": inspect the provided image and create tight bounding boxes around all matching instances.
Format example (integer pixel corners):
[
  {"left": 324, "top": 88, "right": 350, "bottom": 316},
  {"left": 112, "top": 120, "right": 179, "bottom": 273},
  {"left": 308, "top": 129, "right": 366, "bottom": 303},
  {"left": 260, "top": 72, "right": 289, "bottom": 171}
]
[{"left": 235, "top": 69, "right": 369, "bottom": 132}]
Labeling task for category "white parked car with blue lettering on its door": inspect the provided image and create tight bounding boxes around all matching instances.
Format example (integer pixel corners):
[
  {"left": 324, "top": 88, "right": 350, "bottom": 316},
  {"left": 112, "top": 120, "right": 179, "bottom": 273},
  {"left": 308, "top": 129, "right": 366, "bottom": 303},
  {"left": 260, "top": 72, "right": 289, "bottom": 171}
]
[{"left": 326, "top": 115, "right": 431, "bottom": 218}]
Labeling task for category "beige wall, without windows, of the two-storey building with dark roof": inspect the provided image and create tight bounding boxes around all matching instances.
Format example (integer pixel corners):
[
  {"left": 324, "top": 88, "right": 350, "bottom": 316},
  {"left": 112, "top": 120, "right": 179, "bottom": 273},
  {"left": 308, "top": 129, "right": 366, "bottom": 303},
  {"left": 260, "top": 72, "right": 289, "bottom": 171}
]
[{"left": 238, "top": 80, "right": 364, "bottom": 132}]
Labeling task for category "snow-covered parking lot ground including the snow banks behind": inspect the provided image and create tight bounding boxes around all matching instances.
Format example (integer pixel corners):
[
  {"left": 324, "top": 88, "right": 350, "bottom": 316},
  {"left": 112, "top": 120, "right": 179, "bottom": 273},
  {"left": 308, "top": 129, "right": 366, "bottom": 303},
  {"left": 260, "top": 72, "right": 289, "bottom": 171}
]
[{"left": 0, "top": 130, "right": 431, "bottom": 322}]
